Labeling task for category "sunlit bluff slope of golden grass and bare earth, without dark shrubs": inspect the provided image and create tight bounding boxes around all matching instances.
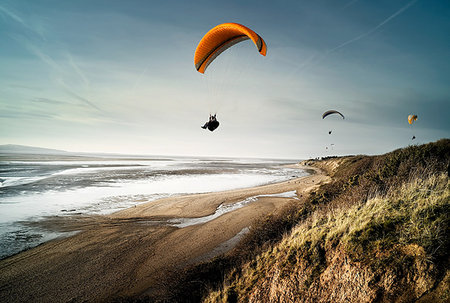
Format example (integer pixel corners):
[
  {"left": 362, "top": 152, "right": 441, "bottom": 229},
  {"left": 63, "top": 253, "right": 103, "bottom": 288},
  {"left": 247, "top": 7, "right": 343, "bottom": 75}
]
[{"left": 205, "top": 174, "right": 450, "bottom": 302}]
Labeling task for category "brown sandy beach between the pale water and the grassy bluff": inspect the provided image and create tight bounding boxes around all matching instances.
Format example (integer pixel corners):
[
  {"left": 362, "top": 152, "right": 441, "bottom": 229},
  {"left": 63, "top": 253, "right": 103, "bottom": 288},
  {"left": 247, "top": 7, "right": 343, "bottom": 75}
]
[{"left": 0, "top": 167, "right": 328, "bottom": 302}]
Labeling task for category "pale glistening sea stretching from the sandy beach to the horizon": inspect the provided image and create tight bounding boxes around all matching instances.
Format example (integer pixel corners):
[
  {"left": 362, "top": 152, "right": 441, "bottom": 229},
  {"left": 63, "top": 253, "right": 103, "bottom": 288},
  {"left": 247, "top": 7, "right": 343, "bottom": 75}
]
[{"left": 0, "top": 153, "right": 308, "bottom": 259}]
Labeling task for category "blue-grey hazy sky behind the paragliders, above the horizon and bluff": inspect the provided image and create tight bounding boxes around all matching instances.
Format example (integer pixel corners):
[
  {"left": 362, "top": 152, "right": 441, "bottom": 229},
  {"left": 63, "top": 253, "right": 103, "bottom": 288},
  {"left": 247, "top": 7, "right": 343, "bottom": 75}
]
[{"left": 0, "top": 0, "right": 450, "bottom": 159}]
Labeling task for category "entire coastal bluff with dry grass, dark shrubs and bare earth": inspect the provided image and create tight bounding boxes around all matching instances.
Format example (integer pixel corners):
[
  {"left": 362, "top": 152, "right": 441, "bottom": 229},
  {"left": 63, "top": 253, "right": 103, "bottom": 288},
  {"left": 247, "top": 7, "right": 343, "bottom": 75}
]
[{"left": 156, "top": 139, "right": 450, "bottom": 302}]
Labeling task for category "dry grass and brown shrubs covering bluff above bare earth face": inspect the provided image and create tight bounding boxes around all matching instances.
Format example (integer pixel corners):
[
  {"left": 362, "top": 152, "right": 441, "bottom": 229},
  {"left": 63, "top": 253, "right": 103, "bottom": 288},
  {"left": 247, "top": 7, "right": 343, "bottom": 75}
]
[{"left": 201, "top": 140, "right": 450, "bottom": 302}]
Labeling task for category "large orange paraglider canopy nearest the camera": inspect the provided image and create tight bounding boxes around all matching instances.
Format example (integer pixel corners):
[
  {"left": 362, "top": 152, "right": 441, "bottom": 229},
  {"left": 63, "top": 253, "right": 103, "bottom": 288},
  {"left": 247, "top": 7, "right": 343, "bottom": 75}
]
[{"left": 194, "top": 23, "right": 267, "bottom": 74}]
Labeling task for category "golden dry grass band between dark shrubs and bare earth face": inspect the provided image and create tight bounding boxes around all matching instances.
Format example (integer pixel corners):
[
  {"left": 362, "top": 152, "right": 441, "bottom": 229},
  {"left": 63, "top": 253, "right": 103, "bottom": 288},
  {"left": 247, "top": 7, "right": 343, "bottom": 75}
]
[{"left": 205, "top": 174, "right": 450, "bottom": 302}]
